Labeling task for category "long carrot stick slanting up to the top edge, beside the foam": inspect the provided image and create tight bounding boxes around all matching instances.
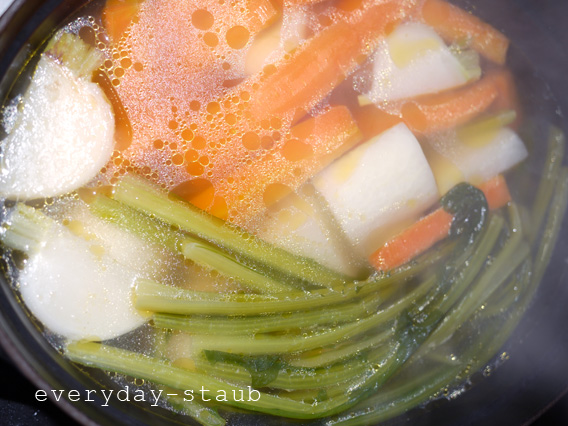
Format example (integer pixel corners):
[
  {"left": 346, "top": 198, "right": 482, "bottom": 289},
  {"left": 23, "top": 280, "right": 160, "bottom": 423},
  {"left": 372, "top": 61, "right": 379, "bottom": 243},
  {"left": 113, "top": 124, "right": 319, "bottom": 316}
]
[{"left": 250, "top": 0, "right": 415, "bottom": 117}]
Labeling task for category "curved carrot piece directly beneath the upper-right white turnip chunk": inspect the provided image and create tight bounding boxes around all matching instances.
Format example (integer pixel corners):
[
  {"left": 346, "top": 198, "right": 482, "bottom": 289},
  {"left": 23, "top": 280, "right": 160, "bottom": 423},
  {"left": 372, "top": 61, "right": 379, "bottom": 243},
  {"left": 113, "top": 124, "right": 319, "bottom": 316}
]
[{"left": 402, "top": 73, "right": 500, "bottom": 133}]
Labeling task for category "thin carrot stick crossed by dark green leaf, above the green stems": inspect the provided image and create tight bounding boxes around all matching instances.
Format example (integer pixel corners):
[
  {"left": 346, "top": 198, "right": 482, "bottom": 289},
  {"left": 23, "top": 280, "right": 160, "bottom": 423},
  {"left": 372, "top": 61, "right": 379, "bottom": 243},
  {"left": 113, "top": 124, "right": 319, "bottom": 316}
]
[{"left": 369, "top": 175, "right": 511, "bottom": 271}]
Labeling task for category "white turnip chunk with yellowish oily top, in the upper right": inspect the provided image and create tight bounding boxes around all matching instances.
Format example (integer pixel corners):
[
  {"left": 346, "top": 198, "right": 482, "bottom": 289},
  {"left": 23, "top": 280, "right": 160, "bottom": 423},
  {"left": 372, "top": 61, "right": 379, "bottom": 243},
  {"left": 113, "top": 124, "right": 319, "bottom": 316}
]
[{"left": 365, "top": 22, "right": 470, "bottom": 105}]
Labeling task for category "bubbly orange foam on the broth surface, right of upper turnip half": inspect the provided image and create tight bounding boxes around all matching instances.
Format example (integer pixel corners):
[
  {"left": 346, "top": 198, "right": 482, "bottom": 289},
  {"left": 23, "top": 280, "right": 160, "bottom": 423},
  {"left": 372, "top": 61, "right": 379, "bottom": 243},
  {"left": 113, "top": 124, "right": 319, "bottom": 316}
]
[{"left": 85, "top": 0, "right": 358, "bottom": 230}]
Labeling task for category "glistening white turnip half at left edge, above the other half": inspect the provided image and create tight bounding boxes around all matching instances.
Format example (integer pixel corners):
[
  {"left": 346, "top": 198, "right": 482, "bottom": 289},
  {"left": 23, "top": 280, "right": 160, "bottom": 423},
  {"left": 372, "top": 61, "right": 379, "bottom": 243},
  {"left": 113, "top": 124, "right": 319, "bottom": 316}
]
[{"left": 0, "top": 39, "right": 114, "bottom": 200}]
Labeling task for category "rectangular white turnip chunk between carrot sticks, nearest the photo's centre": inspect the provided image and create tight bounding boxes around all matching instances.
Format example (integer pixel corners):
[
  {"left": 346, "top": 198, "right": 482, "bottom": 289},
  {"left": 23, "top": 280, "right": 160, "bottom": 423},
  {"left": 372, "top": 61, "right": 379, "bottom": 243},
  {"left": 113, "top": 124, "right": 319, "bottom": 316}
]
[{"left": 313, "top": 123, "right": 438, "bottom": 256}]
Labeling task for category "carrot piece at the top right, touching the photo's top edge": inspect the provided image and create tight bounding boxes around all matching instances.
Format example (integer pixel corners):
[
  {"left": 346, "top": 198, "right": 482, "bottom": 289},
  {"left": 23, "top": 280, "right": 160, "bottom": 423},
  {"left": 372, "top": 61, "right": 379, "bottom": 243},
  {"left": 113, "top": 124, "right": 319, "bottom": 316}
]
[{"left": 422, "top": 0, "right": 509, "bottom": 65}]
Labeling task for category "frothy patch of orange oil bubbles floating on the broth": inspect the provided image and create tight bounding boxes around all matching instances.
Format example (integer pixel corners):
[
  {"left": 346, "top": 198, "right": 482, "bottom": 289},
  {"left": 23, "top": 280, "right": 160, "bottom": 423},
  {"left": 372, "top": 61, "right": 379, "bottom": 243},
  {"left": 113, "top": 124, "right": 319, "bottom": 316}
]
[{"left": 93, "top": 0, "right": 378, "bottom": 230}]
